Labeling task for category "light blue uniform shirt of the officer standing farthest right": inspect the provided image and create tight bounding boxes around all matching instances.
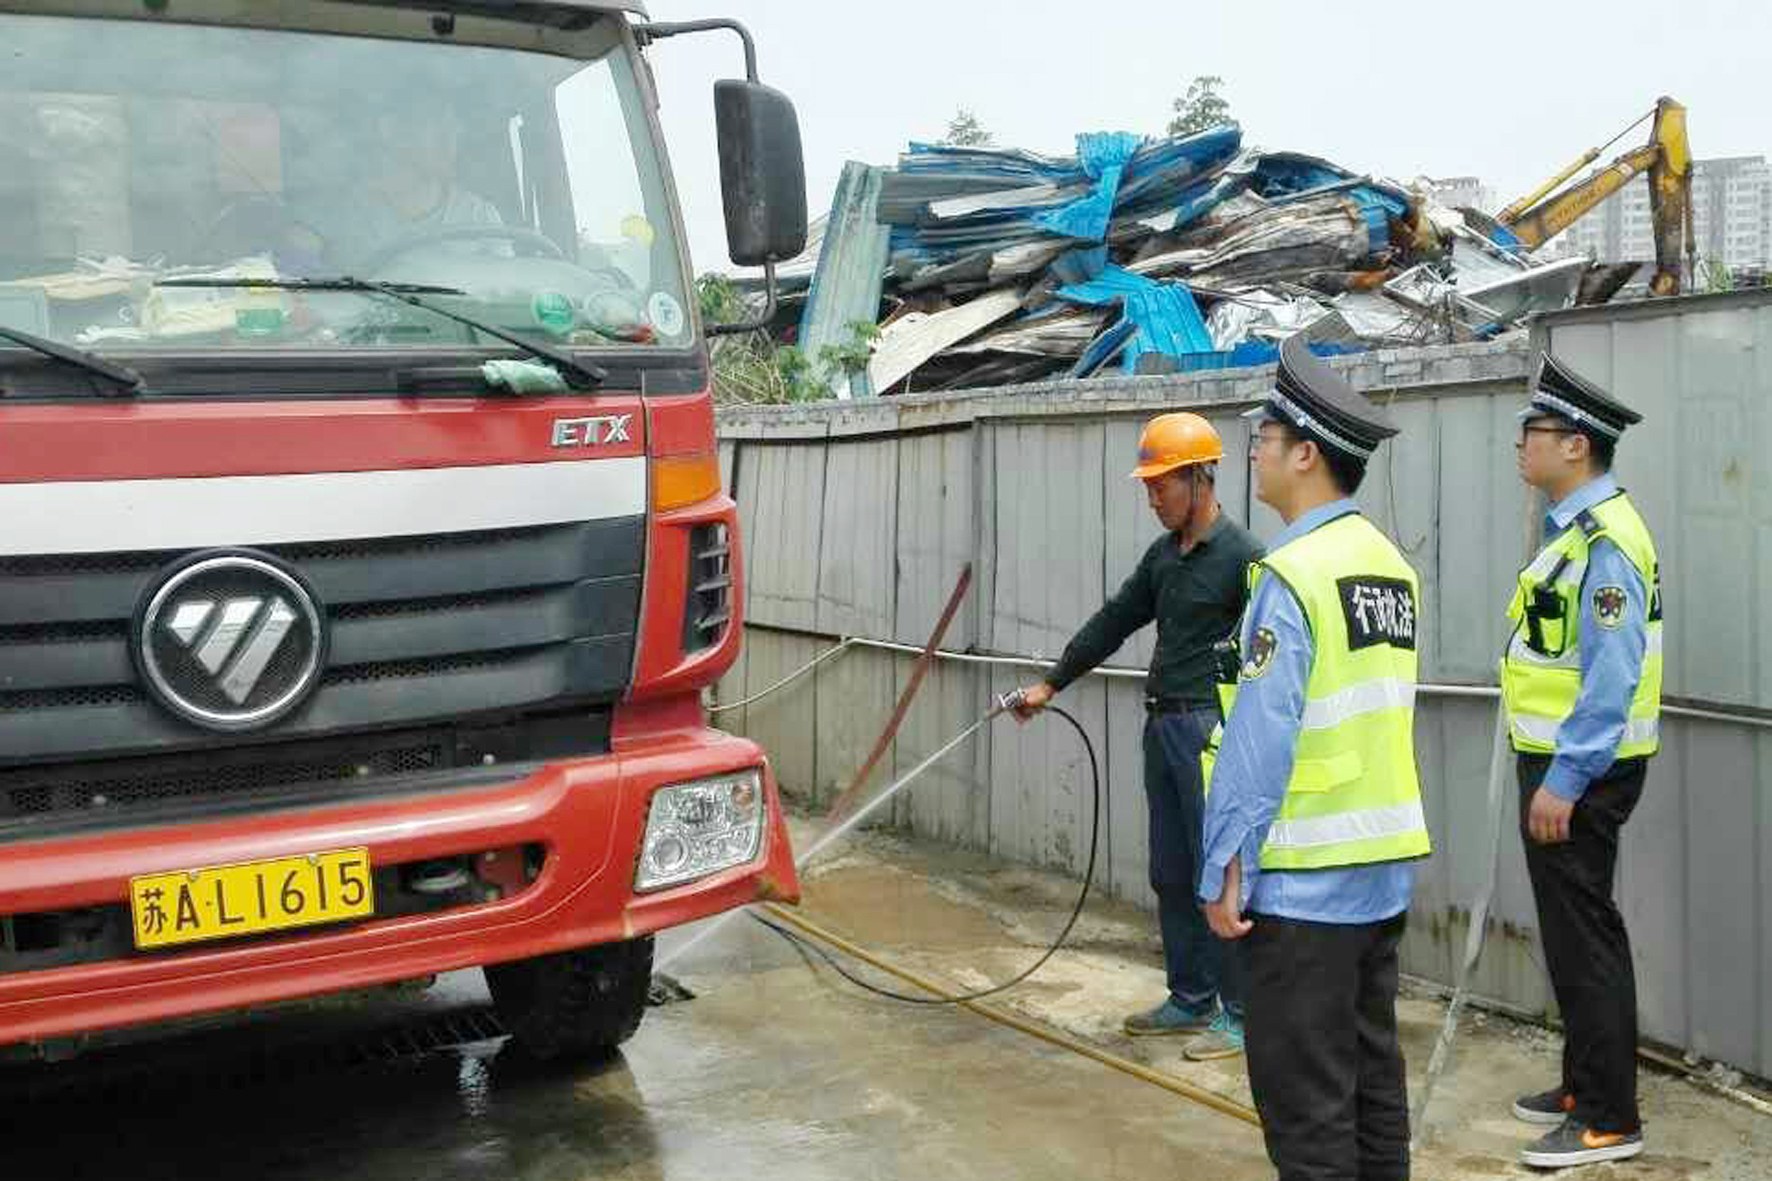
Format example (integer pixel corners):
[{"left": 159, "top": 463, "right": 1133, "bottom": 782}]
[{"left": 1543, "top": 475, "right": 1650, "bottom": 802}]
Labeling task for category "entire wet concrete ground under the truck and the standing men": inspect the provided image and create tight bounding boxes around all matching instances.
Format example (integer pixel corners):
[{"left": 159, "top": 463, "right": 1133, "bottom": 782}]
[{"left": 0, "top": 819, "right": 1772, "bottom": 1181}]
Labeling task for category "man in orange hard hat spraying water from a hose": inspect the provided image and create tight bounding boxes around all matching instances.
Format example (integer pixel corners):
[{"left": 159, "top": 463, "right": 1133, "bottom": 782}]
[{"left": 1017, "top": 413, "right": 1262, "bottom": 1060}]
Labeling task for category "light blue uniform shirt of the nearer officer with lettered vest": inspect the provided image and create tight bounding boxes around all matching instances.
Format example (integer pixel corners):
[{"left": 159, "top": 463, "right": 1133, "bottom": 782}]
[{"left": 1200, "top": 498, "right": 1416, "bottom": 922}]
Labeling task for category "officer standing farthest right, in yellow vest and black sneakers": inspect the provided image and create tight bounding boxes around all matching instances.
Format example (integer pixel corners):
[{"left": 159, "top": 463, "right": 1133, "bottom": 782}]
[{"left": 1501, "top": 356, "right": 1662, "bottom": 1169}]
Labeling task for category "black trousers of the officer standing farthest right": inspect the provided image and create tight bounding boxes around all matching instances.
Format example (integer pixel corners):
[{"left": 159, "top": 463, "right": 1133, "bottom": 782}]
[{"left": 1519, "top": 754, "right": 1648, "bottom": 1131}]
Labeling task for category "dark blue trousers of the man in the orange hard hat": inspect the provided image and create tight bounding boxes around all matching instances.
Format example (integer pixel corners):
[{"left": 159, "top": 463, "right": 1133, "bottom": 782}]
[{"left": 1145, "top": 706, "right": 1242, "bottom": 1016}]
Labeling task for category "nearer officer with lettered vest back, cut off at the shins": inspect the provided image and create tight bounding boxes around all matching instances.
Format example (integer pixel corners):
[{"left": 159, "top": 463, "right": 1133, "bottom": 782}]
[{"left": 1200, "top": 337, "right": 1430, "bottom": 1181}]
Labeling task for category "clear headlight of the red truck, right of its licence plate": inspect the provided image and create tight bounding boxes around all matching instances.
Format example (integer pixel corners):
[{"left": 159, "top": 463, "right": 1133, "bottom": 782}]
[{"left": 634, "top": 768, "right": 764, "bottom": 890}]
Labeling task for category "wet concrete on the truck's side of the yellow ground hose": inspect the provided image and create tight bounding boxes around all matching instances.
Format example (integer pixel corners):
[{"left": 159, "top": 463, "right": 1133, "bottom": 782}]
[{"left": 0, "top": 868, "right": 1265, "bottom": 1181}]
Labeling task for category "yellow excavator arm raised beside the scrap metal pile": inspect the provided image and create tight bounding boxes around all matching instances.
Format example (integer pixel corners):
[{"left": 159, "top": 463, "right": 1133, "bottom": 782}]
[{"left": 1496, "top": 98, "right": 1696, "bottom": 294}]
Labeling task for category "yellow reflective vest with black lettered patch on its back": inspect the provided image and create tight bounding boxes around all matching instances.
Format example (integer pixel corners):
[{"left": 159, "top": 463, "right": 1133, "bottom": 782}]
[{"left": 1201, "top": 512, "right": 1434, "bottom": 871}]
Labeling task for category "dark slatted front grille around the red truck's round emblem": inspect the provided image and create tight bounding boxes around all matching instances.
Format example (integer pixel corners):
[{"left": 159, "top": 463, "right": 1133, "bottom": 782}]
[{"left": 0, "top": 518, "right": 645, "bottom": 832}]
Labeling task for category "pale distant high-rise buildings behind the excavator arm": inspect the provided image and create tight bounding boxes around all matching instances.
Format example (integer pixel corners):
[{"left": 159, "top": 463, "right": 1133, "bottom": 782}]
[{"left": 1563, "top": 156, "right": 1772, "bottom": 270}]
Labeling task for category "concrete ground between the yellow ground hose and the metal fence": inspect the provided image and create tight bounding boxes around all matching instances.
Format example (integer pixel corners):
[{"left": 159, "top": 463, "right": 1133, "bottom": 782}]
[{"left": 776, "top": 833, "right": 1772, "bottom": 1181}]
